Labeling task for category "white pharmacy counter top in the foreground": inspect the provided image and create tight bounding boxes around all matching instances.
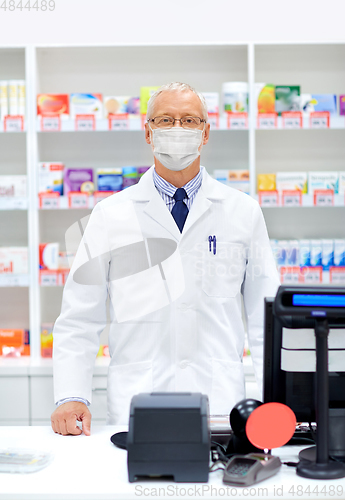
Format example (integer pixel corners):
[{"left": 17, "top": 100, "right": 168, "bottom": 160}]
[{"left": 0, "top": 426, "right": 345, "bottom": 500}]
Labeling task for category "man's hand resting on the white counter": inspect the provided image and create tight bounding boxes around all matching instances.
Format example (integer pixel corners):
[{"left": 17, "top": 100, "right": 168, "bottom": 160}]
[{"left": 51, "top": 401, "right": 91, "bottom": 436}]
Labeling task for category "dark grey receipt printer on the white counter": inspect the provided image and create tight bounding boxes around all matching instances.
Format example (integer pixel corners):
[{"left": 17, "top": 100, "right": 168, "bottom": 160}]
[{"left": 127, "top": 392, "right": 210, "bottom": 483}]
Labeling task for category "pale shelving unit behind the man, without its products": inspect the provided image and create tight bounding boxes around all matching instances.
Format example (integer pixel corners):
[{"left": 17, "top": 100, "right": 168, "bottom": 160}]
[{"left": 0, "top": 43, "right": 345, "bottom": 421}]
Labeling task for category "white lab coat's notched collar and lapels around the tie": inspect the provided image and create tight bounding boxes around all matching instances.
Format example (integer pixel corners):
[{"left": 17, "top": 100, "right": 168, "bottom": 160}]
[{"left": 132, "top": 166, "right": 225, "bottom": 241}]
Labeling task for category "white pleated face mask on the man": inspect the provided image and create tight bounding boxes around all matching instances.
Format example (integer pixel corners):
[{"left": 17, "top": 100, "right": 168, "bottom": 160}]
[{"left": 150, "top": 127, "right": 204, "bottom": 172}]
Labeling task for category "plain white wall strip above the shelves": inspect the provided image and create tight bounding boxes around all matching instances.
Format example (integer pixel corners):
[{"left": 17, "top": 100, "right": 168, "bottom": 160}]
[{"left": 0, "top": 0, "right": 345, "bottom": 45}]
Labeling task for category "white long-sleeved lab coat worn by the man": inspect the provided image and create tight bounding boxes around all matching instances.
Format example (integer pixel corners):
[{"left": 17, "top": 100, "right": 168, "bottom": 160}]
[{"left": 53, "top": 168, "right": 279, "bottom": 424}]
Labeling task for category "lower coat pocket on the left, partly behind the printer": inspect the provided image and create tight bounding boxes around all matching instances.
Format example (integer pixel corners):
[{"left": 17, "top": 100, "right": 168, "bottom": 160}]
[{"left": 107, "top": 361, "right": 153, "bottom": 425}]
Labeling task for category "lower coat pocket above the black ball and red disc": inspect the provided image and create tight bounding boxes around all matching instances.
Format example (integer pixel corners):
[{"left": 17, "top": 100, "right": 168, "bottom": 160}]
[{"left": 210, "top": 358, "right": 245, "bottom": 415}]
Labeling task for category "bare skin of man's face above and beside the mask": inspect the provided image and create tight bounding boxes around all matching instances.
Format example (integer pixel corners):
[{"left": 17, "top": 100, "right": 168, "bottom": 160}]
[{"left": 145, "top": 90, "right": 210, "bottom": 145}]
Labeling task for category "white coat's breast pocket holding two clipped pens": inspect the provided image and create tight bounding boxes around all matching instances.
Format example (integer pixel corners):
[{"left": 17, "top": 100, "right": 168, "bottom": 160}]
[{"left": 202, "top": 241, "right": 246, "bottom": 298}]
